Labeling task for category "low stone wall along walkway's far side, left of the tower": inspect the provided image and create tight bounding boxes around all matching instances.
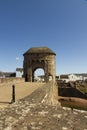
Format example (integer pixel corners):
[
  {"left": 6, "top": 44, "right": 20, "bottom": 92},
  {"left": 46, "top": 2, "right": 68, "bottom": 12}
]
[{"left": 0, "top": 78, "right": 24, "bottom": 84}]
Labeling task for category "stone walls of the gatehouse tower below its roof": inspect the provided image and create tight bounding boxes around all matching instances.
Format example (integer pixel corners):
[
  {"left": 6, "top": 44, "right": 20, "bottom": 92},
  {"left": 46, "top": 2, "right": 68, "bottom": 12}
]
[{"left": 24, "top": 53, "right": 55, "bottom": 82}]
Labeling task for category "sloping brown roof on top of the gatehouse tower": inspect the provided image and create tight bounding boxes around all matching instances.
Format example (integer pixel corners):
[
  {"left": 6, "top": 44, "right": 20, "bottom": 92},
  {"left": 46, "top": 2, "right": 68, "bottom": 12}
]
[{"left": 23, "top": 47, "right": 56, "bottom": 55}]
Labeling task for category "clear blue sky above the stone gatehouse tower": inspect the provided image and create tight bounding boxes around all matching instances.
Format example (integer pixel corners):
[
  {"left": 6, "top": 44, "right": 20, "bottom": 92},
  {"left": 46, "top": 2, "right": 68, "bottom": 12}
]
[{"left": 0, "top": 0, "right": 87, "bottom": 75}]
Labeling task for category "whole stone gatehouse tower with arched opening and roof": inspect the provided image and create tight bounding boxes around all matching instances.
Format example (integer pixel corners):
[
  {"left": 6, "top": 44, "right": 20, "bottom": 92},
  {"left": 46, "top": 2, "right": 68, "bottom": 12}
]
[{"left": 23, "top": 47, "right": 56, "bottom": 82}]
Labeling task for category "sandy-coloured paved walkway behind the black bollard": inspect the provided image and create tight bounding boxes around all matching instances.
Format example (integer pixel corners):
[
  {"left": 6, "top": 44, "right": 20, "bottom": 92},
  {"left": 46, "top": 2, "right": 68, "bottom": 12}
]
[{"left": 0, "top": 82, "right": 44, "bottom": 108}]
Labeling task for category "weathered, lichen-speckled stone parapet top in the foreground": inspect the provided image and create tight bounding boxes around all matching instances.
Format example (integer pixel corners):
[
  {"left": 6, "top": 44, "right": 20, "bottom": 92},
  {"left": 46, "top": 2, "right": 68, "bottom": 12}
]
[{"left": 0, "top": 85, "right": 87, "bottom": 130}]
